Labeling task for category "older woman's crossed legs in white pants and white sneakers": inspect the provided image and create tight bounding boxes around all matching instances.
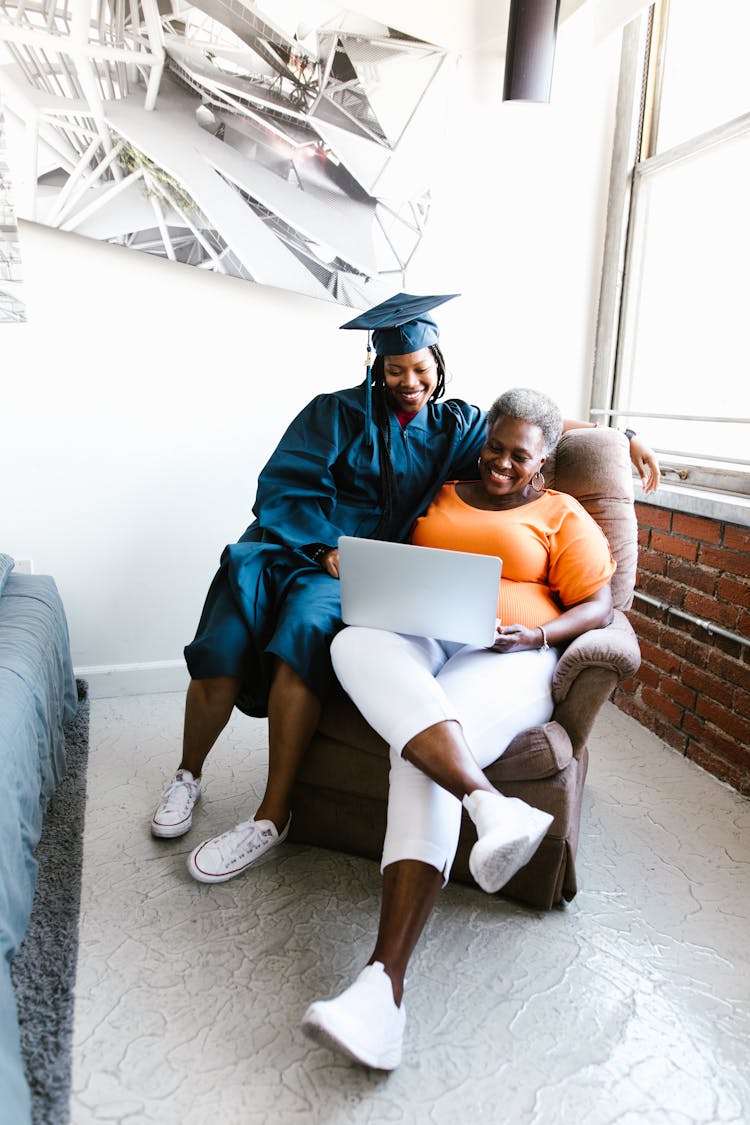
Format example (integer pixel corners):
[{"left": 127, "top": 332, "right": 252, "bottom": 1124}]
[{"left": 302, "top": 629, "right": 555, "bottom": 1070}]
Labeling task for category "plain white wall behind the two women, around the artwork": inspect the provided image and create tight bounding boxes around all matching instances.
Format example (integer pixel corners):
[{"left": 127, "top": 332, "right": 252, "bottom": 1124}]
[{"left": 0, "top": 0, "right": 618, "bottom": 693}]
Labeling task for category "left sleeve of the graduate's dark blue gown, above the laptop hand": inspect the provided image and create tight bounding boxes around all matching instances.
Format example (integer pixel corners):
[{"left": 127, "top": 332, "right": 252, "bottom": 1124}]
[{"left": 253, "top": 394, "right": 362, "bottom": 549}]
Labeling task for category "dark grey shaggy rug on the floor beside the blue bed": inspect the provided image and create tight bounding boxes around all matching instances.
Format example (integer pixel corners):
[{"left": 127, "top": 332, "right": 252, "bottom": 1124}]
[{"left": 10, "top": 680, "right": 89, "bottom": 1125}]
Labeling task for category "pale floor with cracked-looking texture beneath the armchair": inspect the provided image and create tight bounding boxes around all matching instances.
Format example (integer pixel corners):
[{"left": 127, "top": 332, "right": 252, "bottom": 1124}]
[{"left": 72, "top": 694, "right": 750, "bottom": 1125}]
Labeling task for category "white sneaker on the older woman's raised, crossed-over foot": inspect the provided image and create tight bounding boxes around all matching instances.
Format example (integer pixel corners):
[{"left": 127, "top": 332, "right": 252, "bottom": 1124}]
[{"left": 463, "top": 789, "right": 554, "bottom": 894}]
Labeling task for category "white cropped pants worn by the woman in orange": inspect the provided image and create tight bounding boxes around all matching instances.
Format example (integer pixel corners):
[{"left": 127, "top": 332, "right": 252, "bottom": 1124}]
[{"left": 331, "top": 627, "right": 559, "bottom": 880}]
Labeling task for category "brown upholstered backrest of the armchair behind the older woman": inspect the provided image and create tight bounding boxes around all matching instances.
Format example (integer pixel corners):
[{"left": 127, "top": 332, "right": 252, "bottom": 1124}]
[{"left": 543, "top": 428, "right": 638, "bottom": 610}]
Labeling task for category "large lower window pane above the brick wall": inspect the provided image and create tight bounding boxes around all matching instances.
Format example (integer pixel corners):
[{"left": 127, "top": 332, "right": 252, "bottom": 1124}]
[{"left": 617, "top": 131, "right": 750, "bottom": 460}]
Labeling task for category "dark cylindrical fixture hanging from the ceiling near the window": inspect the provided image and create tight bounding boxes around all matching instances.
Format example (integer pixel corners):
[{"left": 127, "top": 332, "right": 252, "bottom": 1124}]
[{"left": 503, "top": 0, "right": 560, "bottom": 101}]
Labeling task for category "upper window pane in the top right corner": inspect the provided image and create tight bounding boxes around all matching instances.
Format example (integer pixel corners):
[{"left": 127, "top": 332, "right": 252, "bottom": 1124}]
[{"left": 657, "top": 0, "right": 750, "bottom": 152}]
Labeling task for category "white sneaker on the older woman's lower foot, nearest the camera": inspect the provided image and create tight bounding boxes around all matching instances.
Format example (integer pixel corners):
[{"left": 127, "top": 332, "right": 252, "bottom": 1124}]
[{"left": 302, "top": 961, "right": 406, "bottom": 1070}]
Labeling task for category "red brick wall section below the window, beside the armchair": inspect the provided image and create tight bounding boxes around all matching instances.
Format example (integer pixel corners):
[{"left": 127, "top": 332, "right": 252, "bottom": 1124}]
[{"left": 614, "top": 503, "right": 750, "bottom": 794}]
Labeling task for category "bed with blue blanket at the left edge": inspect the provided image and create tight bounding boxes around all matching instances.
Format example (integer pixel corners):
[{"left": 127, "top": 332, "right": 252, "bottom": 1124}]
[{"left": 0, "top": 555, "right": 76, "bottom": 1125}]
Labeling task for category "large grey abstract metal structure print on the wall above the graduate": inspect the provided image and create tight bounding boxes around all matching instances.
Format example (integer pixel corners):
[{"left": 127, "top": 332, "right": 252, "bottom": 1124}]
[{"left": 0, "top": 0, "right": 454, "bottom": 307}]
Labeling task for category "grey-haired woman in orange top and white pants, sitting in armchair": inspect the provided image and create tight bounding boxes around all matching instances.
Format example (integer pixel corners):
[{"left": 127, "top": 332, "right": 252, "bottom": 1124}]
[{"left": 304, "top": 389, "right": 615, "bottom": 1070}]
